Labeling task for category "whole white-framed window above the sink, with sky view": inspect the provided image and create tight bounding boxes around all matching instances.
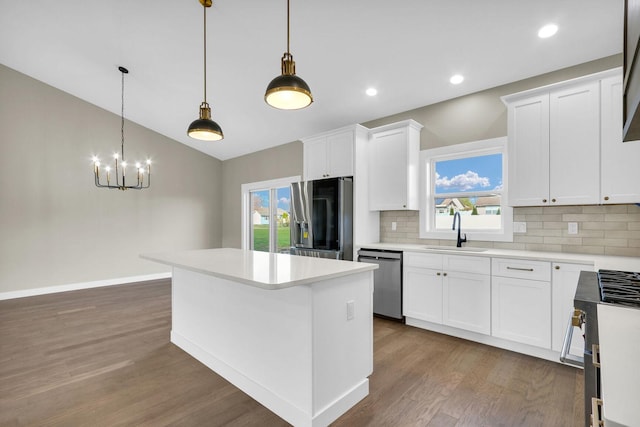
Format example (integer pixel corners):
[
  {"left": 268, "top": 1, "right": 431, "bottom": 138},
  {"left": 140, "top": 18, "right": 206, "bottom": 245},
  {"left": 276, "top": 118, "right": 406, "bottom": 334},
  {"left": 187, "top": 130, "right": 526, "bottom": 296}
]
[{"left": 420, "top": 138, "right": 513, "bottom": 241}]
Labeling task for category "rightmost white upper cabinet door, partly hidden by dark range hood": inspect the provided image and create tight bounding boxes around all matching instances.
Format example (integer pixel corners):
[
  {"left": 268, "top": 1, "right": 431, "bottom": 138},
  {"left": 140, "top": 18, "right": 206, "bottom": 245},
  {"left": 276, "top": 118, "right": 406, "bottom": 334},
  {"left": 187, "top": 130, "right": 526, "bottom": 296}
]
[{"left": 600, "top": 75, "right": 640, "bottom": 203}]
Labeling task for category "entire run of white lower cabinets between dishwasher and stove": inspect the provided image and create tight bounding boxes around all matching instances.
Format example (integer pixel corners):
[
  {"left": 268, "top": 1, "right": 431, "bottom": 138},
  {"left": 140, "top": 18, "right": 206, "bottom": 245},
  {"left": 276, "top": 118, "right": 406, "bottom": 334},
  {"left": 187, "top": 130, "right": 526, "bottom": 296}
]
[{"left": 403, "top": 251, "right": 594, "bottom": 362}]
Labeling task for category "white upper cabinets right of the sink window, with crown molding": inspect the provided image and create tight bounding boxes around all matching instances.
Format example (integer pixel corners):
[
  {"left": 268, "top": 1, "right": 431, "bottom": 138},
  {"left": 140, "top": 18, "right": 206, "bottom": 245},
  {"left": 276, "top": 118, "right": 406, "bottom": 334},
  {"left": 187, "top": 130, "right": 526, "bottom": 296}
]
[{"left": 503, "top": 69, "right": 640, "bottom": 206}]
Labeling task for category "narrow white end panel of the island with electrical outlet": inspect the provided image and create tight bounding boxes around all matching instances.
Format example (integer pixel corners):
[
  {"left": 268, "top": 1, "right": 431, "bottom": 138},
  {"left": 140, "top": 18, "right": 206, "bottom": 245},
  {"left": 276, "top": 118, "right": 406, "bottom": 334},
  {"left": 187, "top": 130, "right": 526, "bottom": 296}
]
[{"left": 313, "top": 271, "right": 373, "bottom": 425}]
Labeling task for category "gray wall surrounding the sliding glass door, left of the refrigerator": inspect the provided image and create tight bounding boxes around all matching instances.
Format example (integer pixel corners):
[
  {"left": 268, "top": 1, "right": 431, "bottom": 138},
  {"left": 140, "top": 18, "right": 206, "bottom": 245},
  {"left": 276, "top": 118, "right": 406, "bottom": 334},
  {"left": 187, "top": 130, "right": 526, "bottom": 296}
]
[{"left": 222, "top": 141, "right": 302, "bottom": 248}]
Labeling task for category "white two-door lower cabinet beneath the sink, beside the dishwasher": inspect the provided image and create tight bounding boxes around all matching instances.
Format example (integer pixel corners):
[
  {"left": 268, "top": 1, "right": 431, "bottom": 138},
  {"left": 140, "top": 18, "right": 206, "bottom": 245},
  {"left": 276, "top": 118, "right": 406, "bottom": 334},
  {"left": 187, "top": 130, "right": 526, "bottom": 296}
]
[{"left": 403, "top": 252, "right": 491, "bottom": 334}]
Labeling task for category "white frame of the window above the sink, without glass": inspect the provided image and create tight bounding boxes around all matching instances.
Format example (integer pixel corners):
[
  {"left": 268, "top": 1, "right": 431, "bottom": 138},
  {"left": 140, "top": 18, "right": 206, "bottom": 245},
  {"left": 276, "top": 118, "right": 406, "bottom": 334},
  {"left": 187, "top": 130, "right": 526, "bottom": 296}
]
[{"left": 419, "top": 137, "right": 513, "bottom": 242}]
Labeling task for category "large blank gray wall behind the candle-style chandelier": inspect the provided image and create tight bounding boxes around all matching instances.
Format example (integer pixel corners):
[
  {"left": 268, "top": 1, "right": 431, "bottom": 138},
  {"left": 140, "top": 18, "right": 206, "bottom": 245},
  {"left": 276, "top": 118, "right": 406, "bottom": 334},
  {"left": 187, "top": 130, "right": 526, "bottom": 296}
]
[{"left": 0, "top": 65, "right": 222, "bottom": 293}]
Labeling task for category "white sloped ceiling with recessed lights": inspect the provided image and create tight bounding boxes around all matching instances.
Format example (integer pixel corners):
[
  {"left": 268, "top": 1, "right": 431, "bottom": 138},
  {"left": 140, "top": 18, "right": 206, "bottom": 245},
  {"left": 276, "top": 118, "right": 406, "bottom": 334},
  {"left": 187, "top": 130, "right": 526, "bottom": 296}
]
[{"left": 0, "top": 0, "right": 623, "bottom": 160}]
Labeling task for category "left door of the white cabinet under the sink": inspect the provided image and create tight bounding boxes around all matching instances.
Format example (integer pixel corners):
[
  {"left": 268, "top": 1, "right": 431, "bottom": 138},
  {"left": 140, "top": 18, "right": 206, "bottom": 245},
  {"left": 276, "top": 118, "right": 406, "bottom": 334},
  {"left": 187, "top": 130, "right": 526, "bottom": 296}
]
[{"left": 402, "top": 266, "right": 442, "bottom": 323}]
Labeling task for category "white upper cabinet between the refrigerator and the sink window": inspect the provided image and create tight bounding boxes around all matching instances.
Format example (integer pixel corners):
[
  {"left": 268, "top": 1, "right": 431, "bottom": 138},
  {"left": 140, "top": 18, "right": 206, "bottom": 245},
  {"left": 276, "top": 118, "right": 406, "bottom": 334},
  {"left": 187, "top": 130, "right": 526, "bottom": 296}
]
[{"left": 369, "top": 120, "right": 423, "bottom": 211}]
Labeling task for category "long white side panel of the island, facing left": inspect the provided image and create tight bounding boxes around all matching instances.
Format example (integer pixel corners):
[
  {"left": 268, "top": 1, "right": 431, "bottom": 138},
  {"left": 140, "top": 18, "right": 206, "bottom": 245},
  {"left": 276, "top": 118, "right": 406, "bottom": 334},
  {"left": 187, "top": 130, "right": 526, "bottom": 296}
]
[{"left": 171, "top": 267, "right": 313, "bottom": 425}]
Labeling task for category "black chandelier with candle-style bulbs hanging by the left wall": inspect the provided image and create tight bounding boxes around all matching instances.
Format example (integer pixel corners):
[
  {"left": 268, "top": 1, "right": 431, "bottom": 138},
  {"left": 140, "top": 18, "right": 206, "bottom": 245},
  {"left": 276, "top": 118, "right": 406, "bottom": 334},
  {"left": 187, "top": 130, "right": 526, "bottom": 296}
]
[{"left": 93, "top": 67, "right": 151, "bottom": 191}]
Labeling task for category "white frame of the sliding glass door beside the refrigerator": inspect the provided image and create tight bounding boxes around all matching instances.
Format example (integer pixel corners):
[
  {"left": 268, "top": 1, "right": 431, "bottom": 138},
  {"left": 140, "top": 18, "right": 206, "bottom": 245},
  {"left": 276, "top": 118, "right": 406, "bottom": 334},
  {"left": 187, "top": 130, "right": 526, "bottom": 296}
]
[{"left": 241, "top": 175, "right": 301, "bottom": 253}]
